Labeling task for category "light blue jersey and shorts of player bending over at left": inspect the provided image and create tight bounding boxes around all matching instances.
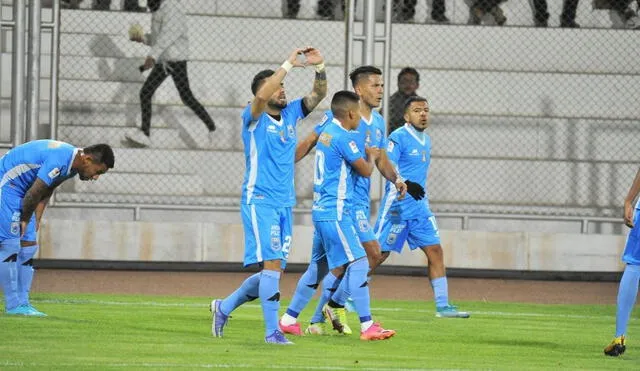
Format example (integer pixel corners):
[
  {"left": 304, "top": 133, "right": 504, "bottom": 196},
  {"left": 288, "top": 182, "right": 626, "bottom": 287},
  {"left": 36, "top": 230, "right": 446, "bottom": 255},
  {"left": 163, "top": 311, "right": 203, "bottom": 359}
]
[{"left": 0, "top": 140, "right": 78, "bottom": 241}]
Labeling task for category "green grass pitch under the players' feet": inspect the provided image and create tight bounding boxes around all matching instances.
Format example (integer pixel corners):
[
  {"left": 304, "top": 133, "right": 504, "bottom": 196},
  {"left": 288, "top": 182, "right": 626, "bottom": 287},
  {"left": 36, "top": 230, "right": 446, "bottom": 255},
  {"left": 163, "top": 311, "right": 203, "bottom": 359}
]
[{"left": 0, "top": 294, "right": 640, "bottom": 371}]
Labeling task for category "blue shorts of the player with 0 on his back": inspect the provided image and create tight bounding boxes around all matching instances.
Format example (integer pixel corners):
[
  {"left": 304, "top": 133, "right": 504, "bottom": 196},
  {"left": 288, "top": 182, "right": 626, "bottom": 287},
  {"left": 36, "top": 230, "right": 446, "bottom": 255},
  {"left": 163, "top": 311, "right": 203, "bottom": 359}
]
[{"left": 313, "top": 218, "right": 367, "bottom": 269}]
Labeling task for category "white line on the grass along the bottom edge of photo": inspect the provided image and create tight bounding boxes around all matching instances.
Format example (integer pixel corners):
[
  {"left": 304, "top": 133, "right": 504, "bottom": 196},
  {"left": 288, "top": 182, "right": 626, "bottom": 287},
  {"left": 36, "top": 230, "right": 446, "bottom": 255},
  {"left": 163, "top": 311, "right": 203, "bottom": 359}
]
[{"left": 0, "top": 361, "right": 443, "bottom": 371}]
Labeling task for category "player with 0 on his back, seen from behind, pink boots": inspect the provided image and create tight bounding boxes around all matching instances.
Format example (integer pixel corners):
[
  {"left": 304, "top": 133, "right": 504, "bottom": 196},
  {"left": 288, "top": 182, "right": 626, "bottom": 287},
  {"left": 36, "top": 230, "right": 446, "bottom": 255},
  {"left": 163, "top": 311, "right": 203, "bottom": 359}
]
[{"left": 311, "top": 90, "right": 395, "bottom": 340}]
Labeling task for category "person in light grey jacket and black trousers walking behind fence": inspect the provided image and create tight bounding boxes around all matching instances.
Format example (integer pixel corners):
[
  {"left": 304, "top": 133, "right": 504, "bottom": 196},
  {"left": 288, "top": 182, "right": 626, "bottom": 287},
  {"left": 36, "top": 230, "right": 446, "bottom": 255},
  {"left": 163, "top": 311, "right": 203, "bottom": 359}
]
[{"left": 125, "top": 0, "right": 216, "bottom": 147}]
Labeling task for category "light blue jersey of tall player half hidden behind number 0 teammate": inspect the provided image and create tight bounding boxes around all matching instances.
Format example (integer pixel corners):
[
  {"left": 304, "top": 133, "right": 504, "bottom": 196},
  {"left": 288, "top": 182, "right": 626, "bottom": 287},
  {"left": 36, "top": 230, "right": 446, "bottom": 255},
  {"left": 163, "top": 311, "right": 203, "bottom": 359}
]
[{"left": 314, "top": 111, "right": 387, "bottom": 209}]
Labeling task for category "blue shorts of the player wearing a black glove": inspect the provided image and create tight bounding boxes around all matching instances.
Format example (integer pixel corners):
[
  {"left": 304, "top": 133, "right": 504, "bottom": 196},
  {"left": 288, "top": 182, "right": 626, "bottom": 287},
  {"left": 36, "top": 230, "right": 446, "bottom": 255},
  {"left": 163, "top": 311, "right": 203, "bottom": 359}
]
[{"left": 376, "top": 216, "right": 440, "bottom": 253}]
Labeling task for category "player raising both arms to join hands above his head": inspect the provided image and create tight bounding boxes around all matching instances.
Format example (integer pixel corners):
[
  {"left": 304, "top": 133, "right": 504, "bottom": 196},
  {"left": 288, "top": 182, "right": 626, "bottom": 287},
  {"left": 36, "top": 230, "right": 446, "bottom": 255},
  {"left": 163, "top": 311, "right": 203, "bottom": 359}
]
[{"left": 211, "top": 47, "right": 327, "bottom": 344}]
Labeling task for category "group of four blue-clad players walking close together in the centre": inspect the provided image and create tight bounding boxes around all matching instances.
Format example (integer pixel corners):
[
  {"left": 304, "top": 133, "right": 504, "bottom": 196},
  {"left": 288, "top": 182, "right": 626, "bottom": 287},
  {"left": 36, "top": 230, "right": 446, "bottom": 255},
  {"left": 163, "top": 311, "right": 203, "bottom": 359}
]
[{"left": 210, "top": 47, "right": 470, "bottom": 345}]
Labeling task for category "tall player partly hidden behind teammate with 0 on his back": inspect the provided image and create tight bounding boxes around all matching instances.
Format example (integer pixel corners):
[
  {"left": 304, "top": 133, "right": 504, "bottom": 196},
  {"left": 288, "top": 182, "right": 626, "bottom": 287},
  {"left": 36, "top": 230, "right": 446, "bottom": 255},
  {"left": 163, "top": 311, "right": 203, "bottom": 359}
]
[{"left": 280, "top": 66, "right": 420, "bottom": 335}]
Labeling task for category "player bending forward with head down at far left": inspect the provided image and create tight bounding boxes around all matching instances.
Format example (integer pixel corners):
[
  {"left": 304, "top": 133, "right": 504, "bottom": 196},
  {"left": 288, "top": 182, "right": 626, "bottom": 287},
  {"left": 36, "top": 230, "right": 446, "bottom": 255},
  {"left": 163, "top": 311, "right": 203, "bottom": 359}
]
[{"left": 0, "top": 140, "right": 114, "bottom": 317}]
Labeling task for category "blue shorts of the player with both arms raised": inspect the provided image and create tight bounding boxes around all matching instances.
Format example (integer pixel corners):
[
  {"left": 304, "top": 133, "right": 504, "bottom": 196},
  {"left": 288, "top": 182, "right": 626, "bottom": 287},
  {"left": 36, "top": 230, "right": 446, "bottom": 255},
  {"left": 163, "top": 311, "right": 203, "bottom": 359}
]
[{"left": 240, "top": 204, "right": 293, "bottom": 269}]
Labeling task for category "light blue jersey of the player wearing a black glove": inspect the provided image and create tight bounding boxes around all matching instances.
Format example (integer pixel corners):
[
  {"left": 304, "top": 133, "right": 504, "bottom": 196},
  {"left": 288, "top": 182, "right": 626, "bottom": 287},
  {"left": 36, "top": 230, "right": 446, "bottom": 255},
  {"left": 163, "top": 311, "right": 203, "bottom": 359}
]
[{"left": 381, "top": 124, "right": 433, "bottom": 220}]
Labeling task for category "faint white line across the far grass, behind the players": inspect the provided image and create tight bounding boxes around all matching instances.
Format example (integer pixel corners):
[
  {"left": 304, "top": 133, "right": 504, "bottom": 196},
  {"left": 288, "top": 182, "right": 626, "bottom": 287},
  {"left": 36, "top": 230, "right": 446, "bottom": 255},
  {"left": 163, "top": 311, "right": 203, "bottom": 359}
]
[{"left": 32, "top": 299, "right": 620, "bottom": 321}]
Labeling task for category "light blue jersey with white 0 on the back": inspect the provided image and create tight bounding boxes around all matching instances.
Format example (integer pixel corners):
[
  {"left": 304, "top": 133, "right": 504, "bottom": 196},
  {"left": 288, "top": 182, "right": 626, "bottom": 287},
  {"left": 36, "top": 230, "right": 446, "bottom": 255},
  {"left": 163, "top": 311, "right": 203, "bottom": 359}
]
[{"left": 311, "top": 119, "right": 363, "bottom": 221}]
